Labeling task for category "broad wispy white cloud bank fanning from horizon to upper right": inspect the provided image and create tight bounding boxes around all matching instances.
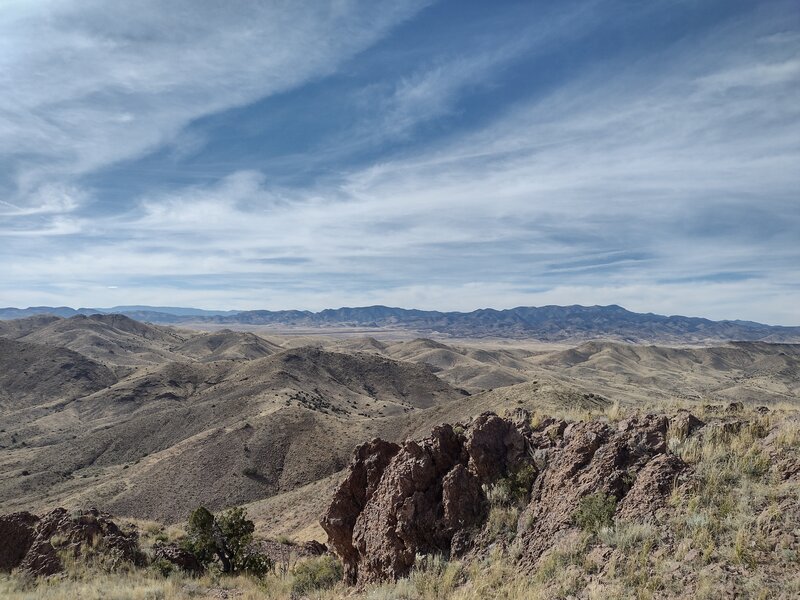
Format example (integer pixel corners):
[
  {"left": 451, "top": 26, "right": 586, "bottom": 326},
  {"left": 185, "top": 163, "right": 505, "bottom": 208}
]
[{"left": 0, "top": 2, "right": 800, "bottom": 324}]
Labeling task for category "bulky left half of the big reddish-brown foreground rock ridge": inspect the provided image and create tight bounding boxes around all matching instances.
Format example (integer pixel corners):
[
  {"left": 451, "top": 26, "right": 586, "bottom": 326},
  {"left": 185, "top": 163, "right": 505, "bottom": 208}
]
[{"left": 321, "top": 413, "right": 532, "bottom": 583}]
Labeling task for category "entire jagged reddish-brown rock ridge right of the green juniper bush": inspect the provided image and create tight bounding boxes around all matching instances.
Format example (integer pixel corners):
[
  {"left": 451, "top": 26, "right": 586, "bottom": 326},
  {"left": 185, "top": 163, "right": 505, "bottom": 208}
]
[{"left": 321, "top": 409, "right": 701, "bottom": 584}]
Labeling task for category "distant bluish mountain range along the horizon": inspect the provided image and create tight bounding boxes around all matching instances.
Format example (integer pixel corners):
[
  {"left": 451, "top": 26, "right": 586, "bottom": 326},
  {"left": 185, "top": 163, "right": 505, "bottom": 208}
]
[{"left": 0, "top": 305, "right": 800, "bottom": 343}]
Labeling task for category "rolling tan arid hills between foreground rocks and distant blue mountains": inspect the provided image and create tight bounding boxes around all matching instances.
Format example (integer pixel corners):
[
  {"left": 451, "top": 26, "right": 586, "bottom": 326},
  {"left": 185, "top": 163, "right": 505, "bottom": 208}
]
[{"left": 0, "top": 315, "right": 800, "bottom": 537}]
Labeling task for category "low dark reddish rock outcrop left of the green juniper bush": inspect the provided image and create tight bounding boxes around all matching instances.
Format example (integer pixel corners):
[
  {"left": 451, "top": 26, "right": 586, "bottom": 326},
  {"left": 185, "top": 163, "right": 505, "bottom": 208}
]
[{"left": 0, "top": 508, "right": 144, "bottom": 575}]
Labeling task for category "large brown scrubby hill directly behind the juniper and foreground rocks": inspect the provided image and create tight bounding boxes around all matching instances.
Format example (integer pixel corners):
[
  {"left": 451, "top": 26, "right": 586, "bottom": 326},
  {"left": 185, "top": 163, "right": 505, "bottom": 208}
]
[{"left": 0, "top": 348, "right": 463, "bottom": 520}]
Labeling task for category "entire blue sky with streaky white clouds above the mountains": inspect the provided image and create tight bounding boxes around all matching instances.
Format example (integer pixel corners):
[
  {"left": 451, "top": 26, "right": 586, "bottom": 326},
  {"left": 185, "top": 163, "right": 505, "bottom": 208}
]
[{"left": 0, "top": 0, "right": 800, "bottom": 325}]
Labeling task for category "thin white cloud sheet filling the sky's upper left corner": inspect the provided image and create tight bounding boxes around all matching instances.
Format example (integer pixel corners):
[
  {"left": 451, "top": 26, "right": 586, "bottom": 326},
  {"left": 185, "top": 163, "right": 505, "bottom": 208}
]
[{"left": 0, "top": 0, "right": 424, "bottom": 205}]
